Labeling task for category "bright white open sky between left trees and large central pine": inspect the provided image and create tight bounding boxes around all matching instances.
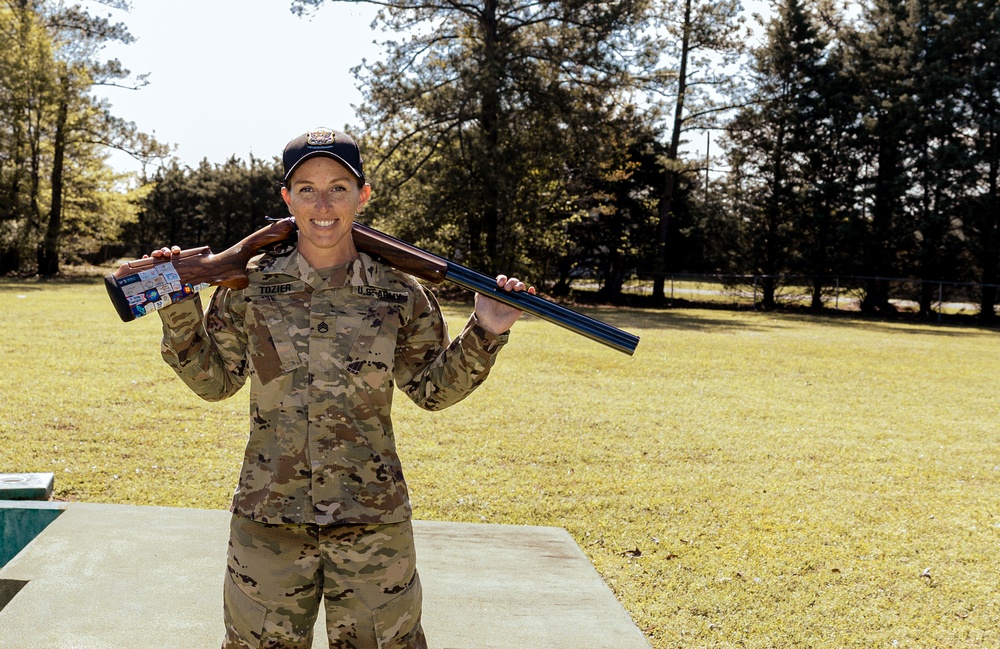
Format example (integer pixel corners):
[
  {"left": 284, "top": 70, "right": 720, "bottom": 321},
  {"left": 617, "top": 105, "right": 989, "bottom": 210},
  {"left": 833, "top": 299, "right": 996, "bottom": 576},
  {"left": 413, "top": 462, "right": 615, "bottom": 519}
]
[{"left": 90, "top": 0, "right": 385, "bottom": 171}]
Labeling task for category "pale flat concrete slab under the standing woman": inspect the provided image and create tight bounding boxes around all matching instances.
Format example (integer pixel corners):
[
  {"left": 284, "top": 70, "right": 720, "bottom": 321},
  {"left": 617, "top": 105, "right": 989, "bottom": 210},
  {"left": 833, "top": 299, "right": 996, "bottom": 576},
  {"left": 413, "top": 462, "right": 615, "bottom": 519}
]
[{"left": 0, "top": 503, "right": 649, "bottom": 649}]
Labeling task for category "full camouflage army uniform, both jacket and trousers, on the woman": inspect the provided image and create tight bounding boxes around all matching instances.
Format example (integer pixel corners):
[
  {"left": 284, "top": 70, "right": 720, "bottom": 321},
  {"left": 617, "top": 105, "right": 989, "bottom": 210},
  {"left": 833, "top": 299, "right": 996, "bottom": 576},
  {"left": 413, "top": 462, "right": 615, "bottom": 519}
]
[{"left": 159, "top": 250, "right": 507, "bottom": 649}]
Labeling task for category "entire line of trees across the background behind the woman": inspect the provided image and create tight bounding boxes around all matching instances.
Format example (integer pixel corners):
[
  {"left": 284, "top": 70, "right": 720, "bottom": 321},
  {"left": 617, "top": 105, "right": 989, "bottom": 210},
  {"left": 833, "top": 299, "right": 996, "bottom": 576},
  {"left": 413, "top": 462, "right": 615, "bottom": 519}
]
[{"left": 0, "top": 0, "right": 1000, "bottom": 321}]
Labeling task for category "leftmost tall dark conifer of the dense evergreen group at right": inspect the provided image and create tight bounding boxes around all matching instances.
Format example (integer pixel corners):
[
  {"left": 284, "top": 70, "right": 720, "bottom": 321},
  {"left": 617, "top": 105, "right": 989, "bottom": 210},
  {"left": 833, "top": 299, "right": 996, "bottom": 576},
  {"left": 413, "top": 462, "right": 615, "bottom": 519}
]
[{"left": 729, "top": 0, "right": 836, "bottom": 308}]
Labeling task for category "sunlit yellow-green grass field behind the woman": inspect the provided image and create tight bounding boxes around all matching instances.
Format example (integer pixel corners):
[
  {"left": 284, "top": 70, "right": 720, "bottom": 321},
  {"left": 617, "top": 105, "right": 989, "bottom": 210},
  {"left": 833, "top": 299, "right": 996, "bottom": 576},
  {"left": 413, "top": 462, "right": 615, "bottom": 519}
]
[{"left": 0, "top": 280, "right": 1000, "bottom": 649}]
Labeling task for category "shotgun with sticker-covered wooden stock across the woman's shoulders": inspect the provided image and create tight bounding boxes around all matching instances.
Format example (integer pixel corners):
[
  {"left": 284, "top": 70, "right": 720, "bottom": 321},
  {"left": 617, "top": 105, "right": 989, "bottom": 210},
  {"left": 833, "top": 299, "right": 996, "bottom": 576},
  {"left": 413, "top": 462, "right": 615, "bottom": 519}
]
[{"left": 104, "top": 217, "right": 639, "bottom": 355}]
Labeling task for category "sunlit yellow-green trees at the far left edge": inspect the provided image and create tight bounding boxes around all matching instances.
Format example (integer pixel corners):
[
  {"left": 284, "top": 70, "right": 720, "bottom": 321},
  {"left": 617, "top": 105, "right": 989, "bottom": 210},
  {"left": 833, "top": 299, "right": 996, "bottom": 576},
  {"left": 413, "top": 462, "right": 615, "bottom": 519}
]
[{"left": 0, "top": 0, "right": 166, "bottom": 275}]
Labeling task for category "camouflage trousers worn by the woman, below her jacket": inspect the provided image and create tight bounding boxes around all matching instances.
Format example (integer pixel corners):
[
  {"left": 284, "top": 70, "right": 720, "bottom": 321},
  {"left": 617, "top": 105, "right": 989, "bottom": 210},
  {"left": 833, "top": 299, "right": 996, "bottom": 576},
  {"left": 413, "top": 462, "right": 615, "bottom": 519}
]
[{"left": 222, "top": 514, "right": 427, "bottom": 649}]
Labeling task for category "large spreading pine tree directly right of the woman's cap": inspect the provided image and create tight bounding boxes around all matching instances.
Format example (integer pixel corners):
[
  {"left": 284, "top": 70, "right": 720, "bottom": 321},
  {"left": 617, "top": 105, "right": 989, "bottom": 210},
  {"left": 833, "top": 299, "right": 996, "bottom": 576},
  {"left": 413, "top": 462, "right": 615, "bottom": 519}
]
[{"left": 290, "top": 0, "right": 644, "bottom": 273}]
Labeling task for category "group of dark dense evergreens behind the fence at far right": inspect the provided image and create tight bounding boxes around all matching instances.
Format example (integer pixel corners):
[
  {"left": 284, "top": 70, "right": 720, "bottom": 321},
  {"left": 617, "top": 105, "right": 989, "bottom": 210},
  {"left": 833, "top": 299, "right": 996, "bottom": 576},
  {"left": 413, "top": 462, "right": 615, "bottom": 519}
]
[{"left": 727, "top": 0, "right": 1000, "bottom": 320}]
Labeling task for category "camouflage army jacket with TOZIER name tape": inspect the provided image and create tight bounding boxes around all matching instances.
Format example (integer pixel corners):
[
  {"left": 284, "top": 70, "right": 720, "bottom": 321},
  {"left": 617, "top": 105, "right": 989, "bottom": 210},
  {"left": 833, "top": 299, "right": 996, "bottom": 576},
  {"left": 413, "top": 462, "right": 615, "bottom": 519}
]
[{"left": 158, "top": 251, "right": 508, "bottom": 525}]
